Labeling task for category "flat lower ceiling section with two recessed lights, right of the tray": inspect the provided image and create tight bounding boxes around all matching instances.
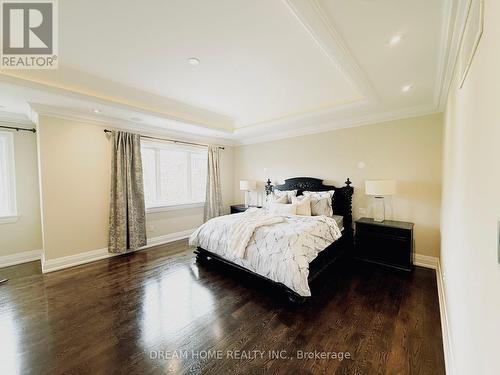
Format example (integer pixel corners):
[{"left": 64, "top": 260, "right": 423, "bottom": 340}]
[{"left": 321, "top": 0, "right": 444, "bottom": 108}]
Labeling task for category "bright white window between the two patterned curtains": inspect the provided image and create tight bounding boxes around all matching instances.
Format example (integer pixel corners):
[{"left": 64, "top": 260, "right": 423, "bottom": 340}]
[{"left": 141, "top": 141, "right": 207, "bottom": 209}]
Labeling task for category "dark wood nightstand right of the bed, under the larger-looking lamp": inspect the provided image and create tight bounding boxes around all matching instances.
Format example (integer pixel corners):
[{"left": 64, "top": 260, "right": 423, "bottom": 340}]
[{"left": 354, "top": 217, "right": 414, "bottom": 271}]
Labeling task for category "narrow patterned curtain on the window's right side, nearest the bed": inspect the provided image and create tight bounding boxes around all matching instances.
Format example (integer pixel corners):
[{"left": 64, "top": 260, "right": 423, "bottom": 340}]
[{"left": 204, "top": 146, "right": 222, "bottom": 221}]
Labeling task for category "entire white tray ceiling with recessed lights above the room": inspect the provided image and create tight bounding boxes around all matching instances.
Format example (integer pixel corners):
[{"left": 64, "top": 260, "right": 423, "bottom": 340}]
[{"left": 0, "top": 0, "right": 452, "bottom": 142}]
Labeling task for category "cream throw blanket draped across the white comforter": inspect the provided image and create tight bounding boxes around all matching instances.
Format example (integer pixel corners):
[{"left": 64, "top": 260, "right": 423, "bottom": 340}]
[{"left": 227, "top": 208, "right": 284, "bottom": 258}]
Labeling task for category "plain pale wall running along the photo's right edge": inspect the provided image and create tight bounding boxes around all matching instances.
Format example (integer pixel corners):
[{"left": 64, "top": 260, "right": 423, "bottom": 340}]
[{"left": 441, "top": 0, "right": 500, "bottom": 375}]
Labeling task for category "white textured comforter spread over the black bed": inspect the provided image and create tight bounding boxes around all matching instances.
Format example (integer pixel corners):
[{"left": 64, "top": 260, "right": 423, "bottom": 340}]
[{"left": 189, "top": 213, "right": 341, "bottom": 296}]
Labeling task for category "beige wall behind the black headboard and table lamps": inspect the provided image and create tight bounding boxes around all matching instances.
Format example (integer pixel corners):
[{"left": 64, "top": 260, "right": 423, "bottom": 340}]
[{"left": 234, "top": 114, "right": 442, "bottom": 256}]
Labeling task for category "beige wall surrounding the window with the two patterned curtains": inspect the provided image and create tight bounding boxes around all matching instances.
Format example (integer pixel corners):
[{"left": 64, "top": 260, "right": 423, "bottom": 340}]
[{"left": 38, "top": 116, "right": 233, "bottom": 260}]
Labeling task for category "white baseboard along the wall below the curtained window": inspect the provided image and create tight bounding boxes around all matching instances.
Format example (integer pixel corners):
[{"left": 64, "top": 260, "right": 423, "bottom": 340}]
[{"left": 42, "top": 229, "right": 195, "bottom": 273}]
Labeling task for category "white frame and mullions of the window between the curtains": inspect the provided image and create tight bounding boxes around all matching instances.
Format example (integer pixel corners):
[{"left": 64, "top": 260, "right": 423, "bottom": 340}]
[{"left": 141, "top": 140, "right": 207, "bottom": 213}]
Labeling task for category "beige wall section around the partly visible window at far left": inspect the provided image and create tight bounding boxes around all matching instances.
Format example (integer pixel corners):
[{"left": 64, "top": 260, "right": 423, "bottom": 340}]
[{"left": 0, "top": 128, "right": 42, "bottom": 256}]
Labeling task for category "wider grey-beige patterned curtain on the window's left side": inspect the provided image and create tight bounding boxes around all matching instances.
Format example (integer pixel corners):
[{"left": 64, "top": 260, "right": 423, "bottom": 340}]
[{"left": 108, "top": 131, "right": 146, "bottom": 253}]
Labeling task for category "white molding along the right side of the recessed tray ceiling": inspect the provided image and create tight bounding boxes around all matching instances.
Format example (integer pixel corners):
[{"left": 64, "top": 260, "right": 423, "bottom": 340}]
[{"left": 283, "top": 0, "right": 378, "bottom": 103}]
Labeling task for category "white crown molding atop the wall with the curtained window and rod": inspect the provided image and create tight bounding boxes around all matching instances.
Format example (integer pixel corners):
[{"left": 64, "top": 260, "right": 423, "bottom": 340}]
[{"left": 29, "top": 103, "right": 235, "bottom": 146}]
